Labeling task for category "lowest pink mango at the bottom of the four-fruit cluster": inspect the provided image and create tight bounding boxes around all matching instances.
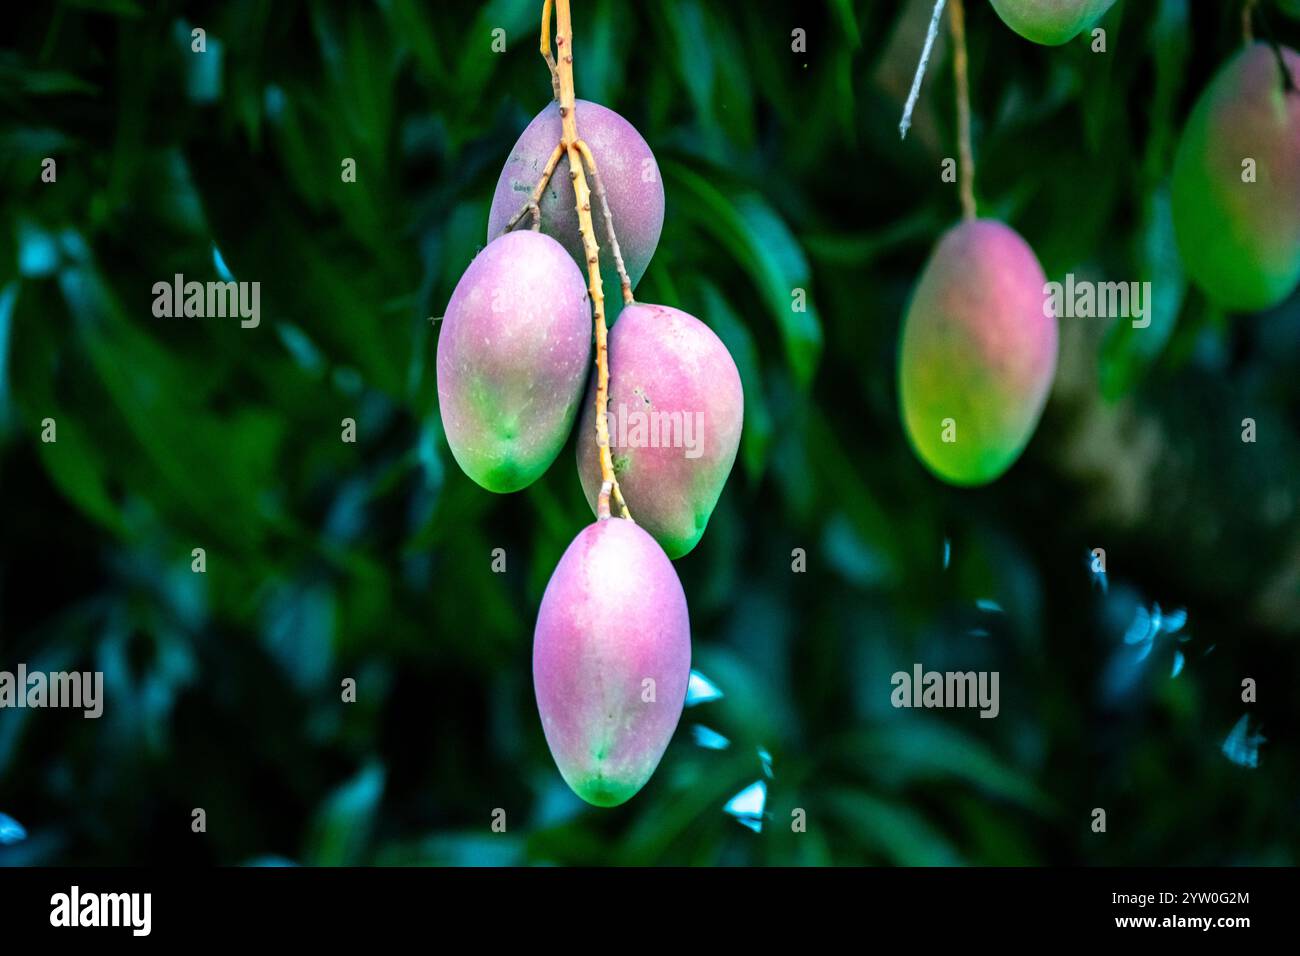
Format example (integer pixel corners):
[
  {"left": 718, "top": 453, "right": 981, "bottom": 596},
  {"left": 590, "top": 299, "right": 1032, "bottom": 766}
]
[{"left": 533, "top": 518, "right": 690, "bottom": 806}]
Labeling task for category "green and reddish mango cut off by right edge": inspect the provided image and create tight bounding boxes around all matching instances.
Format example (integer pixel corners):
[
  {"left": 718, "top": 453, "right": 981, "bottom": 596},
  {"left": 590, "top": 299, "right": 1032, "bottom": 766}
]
[{"left": 1173, "top": 43, "right": 1300, "bottom": 312}]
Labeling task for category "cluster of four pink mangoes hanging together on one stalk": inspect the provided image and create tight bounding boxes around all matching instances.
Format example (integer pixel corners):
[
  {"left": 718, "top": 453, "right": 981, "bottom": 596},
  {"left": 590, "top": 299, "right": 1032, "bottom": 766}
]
[{"left": 437, "top": 100, "right": 745, "bottom": 806}]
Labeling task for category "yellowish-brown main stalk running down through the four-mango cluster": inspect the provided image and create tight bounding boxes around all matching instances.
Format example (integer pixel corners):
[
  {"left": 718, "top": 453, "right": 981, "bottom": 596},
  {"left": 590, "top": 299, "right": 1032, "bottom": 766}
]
[{"left": 542, "top": 0, "right": 632, "bottom": 519}]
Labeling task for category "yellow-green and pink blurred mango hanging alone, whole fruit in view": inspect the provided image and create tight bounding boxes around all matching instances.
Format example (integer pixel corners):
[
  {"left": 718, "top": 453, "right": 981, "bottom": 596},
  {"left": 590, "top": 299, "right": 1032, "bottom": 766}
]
[{"left": 898, "top": 220, "right": 1058, "bottom": 485}]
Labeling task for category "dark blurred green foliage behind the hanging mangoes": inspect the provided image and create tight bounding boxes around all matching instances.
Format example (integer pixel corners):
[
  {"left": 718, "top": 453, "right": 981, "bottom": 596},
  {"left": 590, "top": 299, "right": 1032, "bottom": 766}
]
[{"left": 0, "top": 0, "right": 1300, "bottom": 864}]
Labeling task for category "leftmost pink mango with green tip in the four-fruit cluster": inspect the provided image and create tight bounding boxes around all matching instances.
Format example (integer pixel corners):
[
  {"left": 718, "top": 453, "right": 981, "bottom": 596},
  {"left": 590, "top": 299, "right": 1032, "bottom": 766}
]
[{"left": 438, "top": 229, "right": 592, "bottom": 492}]
